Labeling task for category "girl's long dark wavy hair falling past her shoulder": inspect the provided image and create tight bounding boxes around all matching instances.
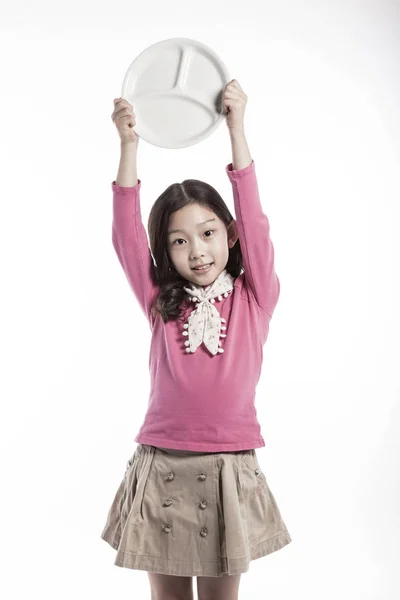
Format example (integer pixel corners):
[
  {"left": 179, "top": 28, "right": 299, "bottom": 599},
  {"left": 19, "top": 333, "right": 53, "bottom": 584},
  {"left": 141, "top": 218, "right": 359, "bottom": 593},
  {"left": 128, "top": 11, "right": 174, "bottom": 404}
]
[{"left": 148, "top": 179, "right": 243, "bottom": 323}]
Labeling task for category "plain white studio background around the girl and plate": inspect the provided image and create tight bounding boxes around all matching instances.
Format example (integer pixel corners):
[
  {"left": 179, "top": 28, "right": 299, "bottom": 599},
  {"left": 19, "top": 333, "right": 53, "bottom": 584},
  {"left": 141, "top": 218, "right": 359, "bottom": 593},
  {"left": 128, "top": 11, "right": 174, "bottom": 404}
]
[{"left": 0, "top": 0, "right": 400, "bottom": 600}]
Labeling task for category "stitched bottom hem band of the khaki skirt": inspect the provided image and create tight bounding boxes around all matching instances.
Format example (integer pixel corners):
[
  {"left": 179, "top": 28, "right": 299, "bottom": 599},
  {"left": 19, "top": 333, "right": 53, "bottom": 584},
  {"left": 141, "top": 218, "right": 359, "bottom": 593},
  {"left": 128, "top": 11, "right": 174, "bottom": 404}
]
[{"left": 101, "top": 529, "right": 292, "bottom": 577}]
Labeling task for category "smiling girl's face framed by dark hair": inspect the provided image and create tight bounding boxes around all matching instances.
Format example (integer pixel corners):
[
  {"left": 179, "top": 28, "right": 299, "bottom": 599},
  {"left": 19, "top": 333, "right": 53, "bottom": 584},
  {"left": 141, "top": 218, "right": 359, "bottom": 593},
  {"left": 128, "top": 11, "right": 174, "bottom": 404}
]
[{"left": 167, "top": 203, "right": 238, "bottom": 286}]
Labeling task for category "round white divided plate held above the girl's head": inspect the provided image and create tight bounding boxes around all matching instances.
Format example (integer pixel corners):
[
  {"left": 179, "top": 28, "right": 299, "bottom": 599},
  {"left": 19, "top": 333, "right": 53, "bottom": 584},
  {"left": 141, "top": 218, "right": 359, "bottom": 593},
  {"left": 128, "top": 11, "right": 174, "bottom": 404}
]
[{"left": 121, "top": 38, "right": 229, "bottom": 148}]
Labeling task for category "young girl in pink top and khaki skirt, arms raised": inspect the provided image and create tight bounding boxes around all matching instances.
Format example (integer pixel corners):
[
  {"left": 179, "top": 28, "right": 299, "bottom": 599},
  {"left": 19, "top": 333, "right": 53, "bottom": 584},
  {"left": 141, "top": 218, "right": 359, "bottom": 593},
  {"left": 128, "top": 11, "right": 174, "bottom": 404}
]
[{"left": 101, "top": 80, "right": 291, "bottom": 600}]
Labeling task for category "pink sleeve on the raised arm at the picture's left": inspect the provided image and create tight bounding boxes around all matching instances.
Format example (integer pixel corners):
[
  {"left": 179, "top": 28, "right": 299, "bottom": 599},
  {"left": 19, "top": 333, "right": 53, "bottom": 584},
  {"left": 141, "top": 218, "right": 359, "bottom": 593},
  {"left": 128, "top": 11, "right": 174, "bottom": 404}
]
[{"left": 111, "top": 179, "right": 159, "bottom": 327}]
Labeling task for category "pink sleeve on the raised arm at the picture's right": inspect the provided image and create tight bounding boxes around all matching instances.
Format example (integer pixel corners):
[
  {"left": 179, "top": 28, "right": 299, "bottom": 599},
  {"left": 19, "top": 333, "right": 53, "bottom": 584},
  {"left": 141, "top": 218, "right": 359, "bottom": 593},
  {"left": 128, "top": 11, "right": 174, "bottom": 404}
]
[{"left": 226, "top": 160, "right": 280, "bottom": 317}]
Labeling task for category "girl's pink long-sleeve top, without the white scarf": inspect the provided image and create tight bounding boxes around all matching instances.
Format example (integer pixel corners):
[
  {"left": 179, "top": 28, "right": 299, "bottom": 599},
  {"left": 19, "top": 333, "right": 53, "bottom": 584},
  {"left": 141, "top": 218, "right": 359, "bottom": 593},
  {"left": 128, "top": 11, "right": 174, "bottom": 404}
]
[{"left": 112, "top": 161, "right": 280, "bottom": 452}]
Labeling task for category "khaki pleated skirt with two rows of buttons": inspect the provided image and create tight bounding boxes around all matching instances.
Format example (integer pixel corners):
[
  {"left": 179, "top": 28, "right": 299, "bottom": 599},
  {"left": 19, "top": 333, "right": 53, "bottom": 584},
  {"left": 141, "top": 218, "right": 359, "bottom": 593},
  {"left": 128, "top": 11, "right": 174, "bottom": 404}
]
[{"left": 101, "top": 444, "right": 292, "bottom": 577}]
